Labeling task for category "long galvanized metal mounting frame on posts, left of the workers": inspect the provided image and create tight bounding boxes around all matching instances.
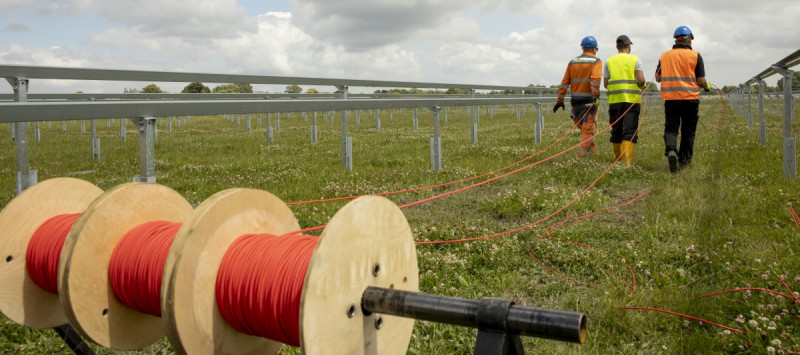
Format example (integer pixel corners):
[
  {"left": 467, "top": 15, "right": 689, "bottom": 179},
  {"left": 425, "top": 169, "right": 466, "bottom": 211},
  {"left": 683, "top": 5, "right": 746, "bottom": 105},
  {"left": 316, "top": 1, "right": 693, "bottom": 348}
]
[{"left": 0, "top": 65, "right": 556, "bottom": 193}]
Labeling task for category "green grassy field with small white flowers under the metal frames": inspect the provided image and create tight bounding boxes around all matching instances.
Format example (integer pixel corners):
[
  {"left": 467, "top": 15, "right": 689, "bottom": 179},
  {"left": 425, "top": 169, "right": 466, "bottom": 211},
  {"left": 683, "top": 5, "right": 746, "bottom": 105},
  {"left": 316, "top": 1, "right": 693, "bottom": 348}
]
[{"left": 0, "top": 99, "right": 800, "bottom": 354}]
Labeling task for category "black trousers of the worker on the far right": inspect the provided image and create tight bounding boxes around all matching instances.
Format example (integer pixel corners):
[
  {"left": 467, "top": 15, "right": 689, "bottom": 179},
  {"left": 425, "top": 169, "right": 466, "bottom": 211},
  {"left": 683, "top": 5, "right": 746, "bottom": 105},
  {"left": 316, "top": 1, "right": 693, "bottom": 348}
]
[{"left": 664, "top": 100, "right": 700, "bottom": 165}]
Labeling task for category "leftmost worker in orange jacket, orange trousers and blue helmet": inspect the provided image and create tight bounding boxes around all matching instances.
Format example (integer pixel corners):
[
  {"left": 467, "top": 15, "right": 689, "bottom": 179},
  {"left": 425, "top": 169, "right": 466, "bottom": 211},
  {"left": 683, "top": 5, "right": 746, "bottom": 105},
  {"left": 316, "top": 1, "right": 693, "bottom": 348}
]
[{"left": 553, "top": 36, "right": 603, "bottom": 159}]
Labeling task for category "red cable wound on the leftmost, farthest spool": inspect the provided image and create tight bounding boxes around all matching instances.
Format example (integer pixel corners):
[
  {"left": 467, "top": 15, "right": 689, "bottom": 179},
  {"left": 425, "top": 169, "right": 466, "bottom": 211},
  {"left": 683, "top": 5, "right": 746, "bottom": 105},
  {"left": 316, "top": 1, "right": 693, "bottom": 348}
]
[{"left": 25, "top": 213, "right": 81, "bottom": 294}]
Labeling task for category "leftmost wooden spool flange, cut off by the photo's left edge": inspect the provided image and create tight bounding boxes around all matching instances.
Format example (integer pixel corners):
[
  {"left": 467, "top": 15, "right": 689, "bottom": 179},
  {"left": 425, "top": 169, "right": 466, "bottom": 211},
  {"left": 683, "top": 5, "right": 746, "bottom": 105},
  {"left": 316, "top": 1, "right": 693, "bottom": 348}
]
[{"left": 0, "top": 178, "right": 103, "bottom": 328}]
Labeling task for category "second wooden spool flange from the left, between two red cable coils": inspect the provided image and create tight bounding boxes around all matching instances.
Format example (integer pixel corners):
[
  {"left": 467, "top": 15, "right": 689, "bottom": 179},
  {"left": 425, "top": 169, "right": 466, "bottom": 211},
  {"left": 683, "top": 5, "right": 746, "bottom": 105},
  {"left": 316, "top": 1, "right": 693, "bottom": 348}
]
[{"left": 59, "top": 183, "right": 193, "bottom": 350}]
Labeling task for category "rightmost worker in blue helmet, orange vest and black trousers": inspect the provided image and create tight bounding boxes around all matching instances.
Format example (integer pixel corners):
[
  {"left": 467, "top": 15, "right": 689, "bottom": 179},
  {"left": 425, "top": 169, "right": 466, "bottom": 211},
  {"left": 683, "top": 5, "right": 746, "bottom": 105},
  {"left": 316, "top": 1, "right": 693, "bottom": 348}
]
[{"left": 656, "top": 26, "right": 711, "bottom": 173}]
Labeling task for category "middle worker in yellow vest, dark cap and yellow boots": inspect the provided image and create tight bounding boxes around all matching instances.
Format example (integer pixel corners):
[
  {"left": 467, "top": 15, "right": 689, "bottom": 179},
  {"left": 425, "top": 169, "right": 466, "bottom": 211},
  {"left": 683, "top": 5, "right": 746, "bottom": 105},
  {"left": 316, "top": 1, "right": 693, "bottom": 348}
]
[{"left": 603, "top": 35, "right": 645, "bottom": 165}]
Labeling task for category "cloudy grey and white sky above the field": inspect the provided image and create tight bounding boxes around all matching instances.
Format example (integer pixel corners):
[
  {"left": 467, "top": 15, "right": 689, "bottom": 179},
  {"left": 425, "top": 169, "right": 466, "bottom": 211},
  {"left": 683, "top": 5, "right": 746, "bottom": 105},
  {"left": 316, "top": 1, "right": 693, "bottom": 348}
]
[{"left": 0, "top": 0, "right": 800, "bottom": 93}]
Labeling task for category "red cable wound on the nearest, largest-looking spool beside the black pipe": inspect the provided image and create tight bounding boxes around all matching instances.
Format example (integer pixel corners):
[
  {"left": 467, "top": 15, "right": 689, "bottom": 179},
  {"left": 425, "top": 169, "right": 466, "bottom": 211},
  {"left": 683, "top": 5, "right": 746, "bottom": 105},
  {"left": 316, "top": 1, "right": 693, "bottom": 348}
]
[{"left": 215, "top": 234, "right": 318, "bottom": 346}]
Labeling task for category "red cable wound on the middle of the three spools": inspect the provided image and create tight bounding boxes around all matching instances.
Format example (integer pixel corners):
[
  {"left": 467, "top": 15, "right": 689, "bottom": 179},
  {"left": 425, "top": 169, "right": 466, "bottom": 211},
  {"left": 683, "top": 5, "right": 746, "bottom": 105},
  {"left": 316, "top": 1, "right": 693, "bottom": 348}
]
[{"left": 108, "top": 221, "right": 181, "bottom": 317}]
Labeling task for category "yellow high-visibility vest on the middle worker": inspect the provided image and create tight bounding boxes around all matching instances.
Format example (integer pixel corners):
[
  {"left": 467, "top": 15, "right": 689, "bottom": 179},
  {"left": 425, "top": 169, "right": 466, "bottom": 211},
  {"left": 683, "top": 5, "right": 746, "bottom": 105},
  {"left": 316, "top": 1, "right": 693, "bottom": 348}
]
[{"left": 606, "top": 53, "right": 642, "bottom": 104}]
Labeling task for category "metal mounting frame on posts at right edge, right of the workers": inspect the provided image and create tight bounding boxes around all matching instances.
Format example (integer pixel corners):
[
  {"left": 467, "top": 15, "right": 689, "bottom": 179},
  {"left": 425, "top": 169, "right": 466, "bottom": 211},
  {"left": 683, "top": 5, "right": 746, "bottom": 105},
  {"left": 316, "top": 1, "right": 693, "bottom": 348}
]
[{"left": 728, "top": 49, "right": 800, "bottom": 179}]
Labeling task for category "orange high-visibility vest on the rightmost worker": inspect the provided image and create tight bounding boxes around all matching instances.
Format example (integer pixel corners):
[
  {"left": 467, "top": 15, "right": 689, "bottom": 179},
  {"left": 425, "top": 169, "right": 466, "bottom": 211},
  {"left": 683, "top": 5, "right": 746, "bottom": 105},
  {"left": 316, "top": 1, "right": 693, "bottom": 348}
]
[{"left": 660, "top": 48, "right": 700, "bottom": 100}]
